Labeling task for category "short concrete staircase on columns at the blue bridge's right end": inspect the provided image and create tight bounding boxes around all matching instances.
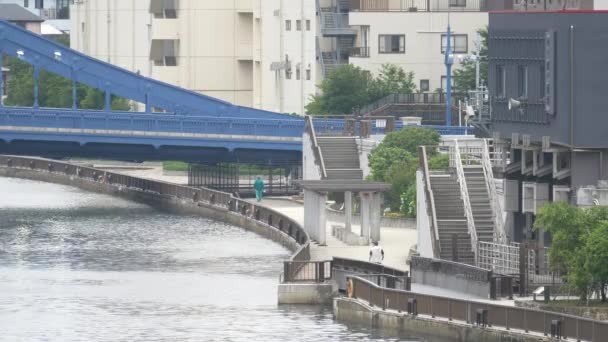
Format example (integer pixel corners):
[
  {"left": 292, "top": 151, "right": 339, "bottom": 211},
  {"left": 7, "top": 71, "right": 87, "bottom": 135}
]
[{"left": 317, "top": 137, "right": 363, "bottom": 180}]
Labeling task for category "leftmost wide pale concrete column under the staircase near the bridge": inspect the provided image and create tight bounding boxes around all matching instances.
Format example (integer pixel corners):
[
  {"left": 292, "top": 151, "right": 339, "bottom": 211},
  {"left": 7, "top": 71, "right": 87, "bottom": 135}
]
[{"left": 304, "top": 189, "right": 327, "bottom": 245}]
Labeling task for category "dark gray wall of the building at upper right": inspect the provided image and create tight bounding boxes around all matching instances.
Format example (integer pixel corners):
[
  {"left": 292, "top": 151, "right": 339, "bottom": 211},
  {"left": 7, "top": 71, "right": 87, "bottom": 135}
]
[{"left": 488, "top": 12, "right": 608, "bottom": 148}]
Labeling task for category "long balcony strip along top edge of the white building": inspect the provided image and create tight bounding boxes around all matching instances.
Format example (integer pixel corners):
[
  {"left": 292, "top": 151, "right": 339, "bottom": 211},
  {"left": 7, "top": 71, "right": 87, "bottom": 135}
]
[{"left": 350, "top": 0, "right": 488, "bottom": 12}]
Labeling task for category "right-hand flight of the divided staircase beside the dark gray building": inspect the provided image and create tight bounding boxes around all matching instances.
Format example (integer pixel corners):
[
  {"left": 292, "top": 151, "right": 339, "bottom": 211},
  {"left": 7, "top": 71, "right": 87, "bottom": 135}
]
[{"left": 464, "top": 166, "right": 494, "bottom": 242}]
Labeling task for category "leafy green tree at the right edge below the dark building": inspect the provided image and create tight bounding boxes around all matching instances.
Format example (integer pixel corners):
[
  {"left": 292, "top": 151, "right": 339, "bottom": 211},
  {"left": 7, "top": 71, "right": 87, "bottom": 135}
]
[{"left": 534, "top": 203, "right": 608, "bottom": 302}]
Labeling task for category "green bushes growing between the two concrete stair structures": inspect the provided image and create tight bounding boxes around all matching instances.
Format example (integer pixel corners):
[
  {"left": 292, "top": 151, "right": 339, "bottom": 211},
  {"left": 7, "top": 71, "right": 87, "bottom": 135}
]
[{"left": 369, "top": 127, "right": 448, "bottom": 217}]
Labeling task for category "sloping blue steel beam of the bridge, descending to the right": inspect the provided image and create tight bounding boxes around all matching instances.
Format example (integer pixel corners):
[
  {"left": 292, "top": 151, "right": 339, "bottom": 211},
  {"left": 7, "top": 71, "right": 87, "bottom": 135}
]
[{"left": 0, "top": 21, "right": 301, "bottom": 120}]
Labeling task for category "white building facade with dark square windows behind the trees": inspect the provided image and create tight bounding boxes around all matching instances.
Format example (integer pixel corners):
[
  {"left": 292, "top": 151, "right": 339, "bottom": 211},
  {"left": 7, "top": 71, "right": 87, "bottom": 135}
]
[{"left": 349, "top": 0, "right": 488, "bottom": 92}]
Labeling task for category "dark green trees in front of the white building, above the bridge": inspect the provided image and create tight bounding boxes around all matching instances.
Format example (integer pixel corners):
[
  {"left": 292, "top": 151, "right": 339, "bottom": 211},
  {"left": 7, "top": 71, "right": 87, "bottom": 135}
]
[{"left": 306, "top": 64, "right": 416, "bottom": 115}]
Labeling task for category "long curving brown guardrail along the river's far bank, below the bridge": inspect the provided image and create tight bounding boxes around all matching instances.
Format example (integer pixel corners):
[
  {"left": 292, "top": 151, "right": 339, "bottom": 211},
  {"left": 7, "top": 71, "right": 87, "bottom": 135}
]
[{"left": 0, "top": 156, "right": 310, "bottom": 270}]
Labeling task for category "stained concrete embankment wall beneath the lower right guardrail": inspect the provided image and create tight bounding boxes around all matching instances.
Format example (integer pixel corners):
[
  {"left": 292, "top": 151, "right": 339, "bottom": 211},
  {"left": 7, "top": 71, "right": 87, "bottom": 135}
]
[{"left": 333, "top": 297, "right": 551, "bottom": 342}]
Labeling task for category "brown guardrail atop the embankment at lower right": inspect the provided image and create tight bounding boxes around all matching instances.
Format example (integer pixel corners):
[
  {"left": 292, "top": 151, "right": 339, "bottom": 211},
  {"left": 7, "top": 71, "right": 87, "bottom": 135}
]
[{"left": 350, "top": 276, "right": 608, "bottom": 342}]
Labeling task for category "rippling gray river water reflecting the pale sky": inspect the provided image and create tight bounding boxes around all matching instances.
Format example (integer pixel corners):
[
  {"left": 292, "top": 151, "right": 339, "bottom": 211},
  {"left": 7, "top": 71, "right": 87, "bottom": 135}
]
[{"left": 0, "top": 178, "right": 428, "bottom": 342}]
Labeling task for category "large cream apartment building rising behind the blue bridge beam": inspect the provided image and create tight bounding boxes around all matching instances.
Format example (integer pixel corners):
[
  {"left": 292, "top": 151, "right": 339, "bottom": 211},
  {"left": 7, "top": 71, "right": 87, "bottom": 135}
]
[{"left": 71, "top": 0, "right": 317, "bottom": 113}]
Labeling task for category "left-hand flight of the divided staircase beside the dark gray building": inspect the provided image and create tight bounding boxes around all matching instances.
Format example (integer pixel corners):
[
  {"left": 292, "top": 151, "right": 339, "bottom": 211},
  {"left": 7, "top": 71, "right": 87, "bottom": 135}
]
[{"left": 430, "top": 170, "right": 475, "bottom": 265}]
